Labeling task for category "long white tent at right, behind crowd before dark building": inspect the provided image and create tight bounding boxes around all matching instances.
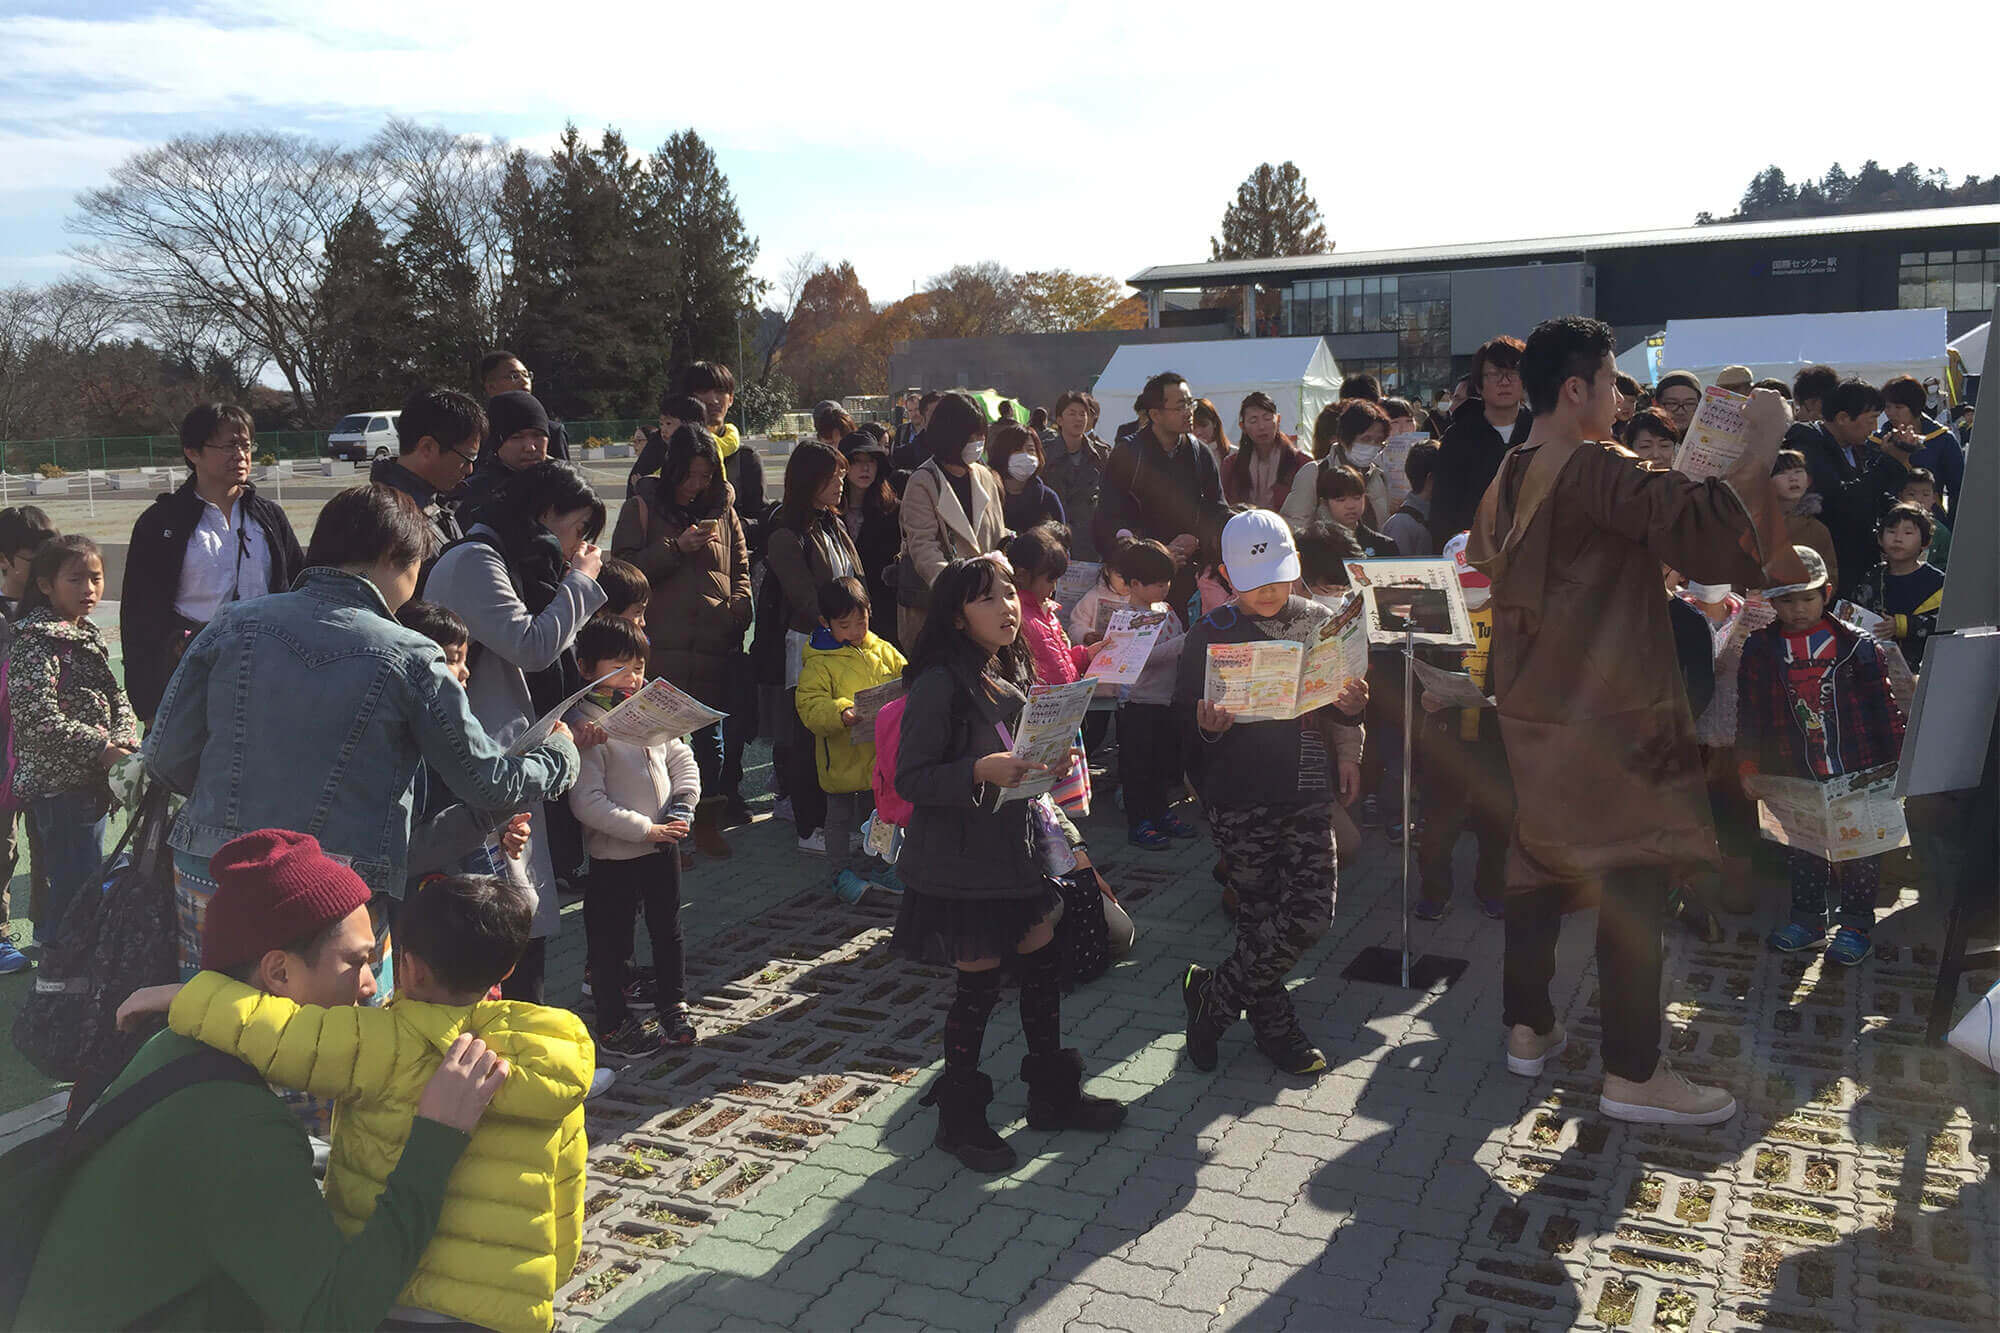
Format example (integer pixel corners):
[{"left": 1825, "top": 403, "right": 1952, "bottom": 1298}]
[{"left": 1660, "top": 310, "right": 1944, "bottom": 384}]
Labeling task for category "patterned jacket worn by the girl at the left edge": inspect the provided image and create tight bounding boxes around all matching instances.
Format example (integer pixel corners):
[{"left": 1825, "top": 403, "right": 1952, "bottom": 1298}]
[{"left": 6, "top": 606, "right": 138, "bottom": 801}]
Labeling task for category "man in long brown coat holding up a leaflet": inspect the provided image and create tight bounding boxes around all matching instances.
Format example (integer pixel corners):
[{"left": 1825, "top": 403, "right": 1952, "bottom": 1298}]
[{"left": 1466, "top": 316, "right": 1794, "bottom": 1125}]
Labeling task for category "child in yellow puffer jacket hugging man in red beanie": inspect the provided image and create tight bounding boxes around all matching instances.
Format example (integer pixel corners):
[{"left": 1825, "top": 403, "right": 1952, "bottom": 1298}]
[{"left": 128, "top": 875, "right": 596, "bottom": 1333}]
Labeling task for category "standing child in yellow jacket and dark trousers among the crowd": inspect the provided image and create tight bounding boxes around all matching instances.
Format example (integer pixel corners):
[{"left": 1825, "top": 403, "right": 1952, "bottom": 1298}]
[{"left": 798, "top": 578, "right": 904, "bottom": 903}]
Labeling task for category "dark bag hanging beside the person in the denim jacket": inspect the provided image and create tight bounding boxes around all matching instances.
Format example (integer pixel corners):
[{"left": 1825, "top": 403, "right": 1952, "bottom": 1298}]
[{"left": 14, "top": 783, "right": 180, "bottom": 1087}]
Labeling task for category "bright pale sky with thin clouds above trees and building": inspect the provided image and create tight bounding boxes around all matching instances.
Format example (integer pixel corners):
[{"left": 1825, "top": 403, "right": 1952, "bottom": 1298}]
[{"left": 0, "top": 0, "right": 2000, "bottom": 302}]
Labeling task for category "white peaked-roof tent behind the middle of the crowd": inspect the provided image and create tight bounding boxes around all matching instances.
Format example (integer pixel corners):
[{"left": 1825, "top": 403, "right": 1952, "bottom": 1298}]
[{"left": 1090, "top": 338, "right": 1342, "bottom": 434}]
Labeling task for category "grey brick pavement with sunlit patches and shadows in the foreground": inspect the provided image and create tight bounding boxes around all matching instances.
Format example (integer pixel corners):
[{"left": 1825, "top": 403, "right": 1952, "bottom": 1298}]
[{"left": 550, "top": 764, "right": 2000, "bottom": 1333}]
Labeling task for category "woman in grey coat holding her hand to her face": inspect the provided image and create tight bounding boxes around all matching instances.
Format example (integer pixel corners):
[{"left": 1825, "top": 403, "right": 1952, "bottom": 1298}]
[{"left": 424, "top": 462, "right": 604, "bottom": 1003}]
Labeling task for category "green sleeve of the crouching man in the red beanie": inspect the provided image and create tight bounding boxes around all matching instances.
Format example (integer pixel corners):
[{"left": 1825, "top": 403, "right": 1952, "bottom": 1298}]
[{"left": 202, "top": 1093, "right": 470, "bottom": 1329}]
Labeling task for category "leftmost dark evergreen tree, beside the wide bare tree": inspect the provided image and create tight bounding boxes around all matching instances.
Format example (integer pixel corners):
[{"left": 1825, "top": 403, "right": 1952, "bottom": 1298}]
[{"left": 314, "top": 204, "right": 414, "bottom": 418}]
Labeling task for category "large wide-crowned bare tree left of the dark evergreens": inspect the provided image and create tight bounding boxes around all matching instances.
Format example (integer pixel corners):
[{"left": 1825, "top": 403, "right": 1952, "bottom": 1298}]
[{"left": 70, "top": 134, "right": 380, "bottom": 416}]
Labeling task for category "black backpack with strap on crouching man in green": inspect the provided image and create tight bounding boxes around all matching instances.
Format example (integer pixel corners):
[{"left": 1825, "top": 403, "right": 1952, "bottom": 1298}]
[{"left": 0, "top": 1047, "right": 264, "bottom": 1329}]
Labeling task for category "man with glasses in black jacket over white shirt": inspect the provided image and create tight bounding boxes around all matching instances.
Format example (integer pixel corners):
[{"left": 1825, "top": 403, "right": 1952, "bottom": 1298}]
[{"left": 118, "top": 402, "right": 306, "bottom": 723}]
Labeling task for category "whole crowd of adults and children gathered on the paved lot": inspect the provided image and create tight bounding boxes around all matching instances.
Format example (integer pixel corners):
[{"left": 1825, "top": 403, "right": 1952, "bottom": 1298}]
[{"left": 0, "top": 318, "right": 1964, "bottom": 1333}]
